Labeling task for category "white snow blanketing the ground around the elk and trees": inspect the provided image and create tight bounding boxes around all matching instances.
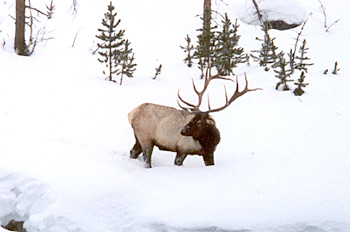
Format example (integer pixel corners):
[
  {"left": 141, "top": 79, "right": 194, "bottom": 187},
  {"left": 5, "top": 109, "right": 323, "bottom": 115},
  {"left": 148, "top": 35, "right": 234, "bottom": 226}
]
[{"left": 0, "top": 0, "right": 350, "bottom": 232}]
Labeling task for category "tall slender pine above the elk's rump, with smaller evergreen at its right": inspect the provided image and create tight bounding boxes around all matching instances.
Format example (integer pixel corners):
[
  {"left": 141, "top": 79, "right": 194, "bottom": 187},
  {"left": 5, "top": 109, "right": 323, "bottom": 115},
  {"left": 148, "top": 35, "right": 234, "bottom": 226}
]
[{"left": 96, "top": 2, "right": 125, "bottom": 81}]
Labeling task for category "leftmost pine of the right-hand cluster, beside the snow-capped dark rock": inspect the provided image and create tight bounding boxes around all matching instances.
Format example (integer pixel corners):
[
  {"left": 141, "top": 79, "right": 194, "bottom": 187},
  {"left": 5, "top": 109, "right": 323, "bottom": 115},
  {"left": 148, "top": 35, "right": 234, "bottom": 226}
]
[{"left": 251, "top": 23, "right": 277, "bottom": 71}]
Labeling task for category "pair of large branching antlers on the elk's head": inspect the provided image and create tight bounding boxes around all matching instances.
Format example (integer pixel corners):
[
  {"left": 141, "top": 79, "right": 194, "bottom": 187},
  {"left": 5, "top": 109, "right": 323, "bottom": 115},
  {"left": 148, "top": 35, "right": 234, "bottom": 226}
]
[{"left": 177, "top": 69, "right": 261, "bottom": 113}]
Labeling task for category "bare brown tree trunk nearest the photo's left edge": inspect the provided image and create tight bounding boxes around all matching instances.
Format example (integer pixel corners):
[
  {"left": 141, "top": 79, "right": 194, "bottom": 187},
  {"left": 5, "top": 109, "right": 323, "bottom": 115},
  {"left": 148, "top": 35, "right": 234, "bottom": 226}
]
[{"left": 15, "top": 0, "right": 27, "bottom": 55}]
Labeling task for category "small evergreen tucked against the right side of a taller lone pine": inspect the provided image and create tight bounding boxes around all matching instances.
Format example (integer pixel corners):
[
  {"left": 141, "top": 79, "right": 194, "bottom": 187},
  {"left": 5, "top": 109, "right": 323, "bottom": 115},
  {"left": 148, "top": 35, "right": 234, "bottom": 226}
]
[{"left": 115, "top": 40, "right": 137, "bottom": 85}]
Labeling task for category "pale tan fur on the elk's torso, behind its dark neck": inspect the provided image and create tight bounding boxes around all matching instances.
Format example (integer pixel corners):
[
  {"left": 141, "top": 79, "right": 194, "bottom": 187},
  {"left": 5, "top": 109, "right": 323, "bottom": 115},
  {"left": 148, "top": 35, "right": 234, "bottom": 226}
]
[{"left": 128, "top": 103, "right": 203, "bottom": 154}]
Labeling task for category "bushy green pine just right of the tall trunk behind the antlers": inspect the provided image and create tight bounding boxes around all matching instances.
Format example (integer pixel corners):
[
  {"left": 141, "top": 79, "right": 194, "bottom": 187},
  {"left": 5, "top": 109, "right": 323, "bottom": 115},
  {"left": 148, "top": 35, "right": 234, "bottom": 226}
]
[{"left": 214, "top": 13, "right": 246, "bottom": 76}]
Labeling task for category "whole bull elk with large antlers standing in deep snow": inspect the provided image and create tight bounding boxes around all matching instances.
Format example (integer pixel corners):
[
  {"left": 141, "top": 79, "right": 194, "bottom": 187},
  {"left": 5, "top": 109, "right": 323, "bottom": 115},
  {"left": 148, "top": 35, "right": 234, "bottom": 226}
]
[{"left": 128, "top": 69, "right": 258, "bottom": 168}]
